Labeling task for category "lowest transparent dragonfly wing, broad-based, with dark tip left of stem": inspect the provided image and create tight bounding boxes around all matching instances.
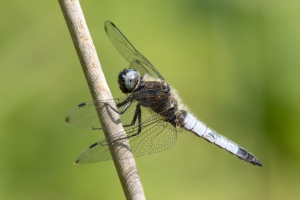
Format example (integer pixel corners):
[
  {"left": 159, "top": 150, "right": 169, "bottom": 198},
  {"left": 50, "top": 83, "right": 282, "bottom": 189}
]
[{"left": 76, "top": 107, "right": 177, "bottom": 164}]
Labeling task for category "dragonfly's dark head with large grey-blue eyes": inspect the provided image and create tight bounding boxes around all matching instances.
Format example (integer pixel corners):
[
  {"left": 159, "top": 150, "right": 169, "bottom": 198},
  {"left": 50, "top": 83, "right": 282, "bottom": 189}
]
[{"left": 118, "top": 69, "right": 139, "bottom": 94}]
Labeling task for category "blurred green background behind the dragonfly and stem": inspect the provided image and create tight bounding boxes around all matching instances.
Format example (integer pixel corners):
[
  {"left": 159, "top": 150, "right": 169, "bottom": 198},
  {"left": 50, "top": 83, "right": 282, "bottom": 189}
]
[{"left": 0, "top": 0, "right": 300, "bottom": 200}]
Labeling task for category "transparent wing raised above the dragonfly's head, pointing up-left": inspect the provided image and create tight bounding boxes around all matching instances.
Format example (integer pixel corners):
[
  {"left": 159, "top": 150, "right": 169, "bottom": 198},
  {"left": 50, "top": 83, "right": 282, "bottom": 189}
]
[{"left": 104, "top": 21, "right": 164, "bottom": 80}]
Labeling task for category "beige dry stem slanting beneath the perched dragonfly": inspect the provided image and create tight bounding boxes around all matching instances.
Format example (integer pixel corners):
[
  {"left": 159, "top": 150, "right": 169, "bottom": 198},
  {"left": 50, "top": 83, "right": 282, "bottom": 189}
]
[{"left": 59, "top": 0, "right": 145, "bottom": 200}]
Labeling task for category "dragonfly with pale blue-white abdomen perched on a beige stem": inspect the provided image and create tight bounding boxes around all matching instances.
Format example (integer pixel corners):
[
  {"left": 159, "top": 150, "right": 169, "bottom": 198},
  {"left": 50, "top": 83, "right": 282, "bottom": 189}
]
[{"left": 66, "top": 21, "right": 263, "bottom": 167}]
